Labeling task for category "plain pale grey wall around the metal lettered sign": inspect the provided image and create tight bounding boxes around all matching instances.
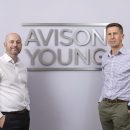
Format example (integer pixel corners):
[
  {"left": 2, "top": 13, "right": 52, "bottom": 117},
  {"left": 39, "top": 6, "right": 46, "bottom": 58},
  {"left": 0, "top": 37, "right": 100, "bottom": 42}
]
[{"left": 0, "top": 0, "right": 130, "bottom": 130}]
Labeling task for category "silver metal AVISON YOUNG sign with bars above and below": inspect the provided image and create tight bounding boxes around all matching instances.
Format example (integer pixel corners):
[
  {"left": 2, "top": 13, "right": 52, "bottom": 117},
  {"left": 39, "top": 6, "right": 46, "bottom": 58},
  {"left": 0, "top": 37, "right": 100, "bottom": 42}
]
[{"left": 22, "top": 23, "right": 106, "bottom": 71}]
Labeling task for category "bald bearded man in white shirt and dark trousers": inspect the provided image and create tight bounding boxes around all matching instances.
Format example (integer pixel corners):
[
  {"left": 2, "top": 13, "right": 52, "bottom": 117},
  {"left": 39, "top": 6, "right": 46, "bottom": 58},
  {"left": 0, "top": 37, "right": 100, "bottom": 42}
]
[{"left": 0, "top": 33, "right": 30, "bottom": 130}]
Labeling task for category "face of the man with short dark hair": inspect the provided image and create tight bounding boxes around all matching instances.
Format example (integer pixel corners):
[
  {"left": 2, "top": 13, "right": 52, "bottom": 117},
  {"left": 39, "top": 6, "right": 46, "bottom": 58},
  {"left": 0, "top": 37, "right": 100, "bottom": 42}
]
[{"left": 106, "top": 26, "right": 124, "bottom": 49}]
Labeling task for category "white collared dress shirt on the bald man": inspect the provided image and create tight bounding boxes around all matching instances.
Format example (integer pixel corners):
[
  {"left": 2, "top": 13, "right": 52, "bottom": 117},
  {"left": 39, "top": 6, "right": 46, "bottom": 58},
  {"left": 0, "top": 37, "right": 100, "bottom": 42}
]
[{"left": 0, "top": 54, "right": 30, "bottom": 118}]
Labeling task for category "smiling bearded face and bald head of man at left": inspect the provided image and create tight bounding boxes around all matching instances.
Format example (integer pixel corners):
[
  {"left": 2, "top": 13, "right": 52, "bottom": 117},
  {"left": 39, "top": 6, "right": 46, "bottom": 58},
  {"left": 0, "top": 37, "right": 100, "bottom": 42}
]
[{"left": 4, "top": 33, "right": 22, "bottom": 57}]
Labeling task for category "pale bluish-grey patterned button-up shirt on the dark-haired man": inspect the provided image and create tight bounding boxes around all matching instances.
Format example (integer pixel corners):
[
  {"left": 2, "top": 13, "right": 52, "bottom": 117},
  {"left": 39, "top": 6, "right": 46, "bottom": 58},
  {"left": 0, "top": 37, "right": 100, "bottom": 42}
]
[{"left": 100, "top": 47, "right": 130, "bottom": 105}]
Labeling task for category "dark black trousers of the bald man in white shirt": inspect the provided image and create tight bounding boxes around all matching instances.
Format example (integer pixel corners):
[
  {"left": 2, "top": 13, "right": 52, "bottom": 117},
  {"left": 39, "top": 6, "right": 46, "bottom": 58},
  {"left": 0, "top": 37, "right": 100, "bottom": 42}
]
[{"left": 0, "top": 110, "right": 30, "bottom": 130}]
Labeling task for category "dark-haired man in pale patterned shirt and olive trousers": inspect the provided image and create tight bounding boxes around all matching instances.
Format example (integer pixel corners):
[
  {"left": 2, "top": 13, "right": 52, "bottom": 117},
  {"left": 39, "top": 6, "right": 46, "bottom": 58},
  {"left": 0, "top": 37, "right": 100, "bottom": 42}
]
[{"left": 99, "top": 23, "right": 130, "bottom": 130}]
